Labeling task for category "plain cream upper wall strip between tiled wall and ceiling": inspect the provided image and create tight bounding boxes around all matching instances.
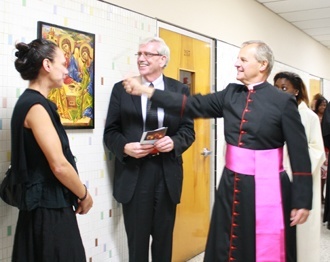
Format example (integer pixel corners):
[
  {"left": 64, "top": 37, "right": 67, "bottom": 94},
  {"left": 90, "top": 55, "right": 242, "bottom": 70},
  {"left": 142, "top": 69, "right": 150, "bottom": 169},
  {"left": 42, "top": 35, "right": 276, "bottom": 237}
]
[{"left": 106, "top": 0, "right": 330, "bottom": 79}]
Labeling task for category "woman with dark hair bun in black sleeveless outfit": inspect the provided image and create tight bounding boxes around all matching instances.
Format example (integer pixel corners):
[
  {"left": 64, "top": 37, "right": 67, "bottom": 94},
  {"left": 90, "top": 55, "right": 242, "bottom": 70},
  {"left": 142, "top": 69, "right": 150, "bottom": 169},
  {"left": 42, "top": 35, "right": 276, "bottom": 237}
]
[{"left": 11, "top": 39, "right": 93, "bottom": 262}]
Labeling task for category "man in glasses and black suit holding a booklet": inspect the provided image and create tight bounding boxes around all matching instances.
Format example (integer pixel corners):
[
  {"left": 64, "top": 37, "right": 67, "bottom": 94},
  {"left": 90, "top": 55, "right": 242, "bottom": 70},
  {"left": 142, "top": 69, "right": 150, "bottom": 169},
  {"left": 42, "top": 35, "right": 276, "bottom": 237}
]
[{"left": 104, "top": 37, "right": 195, "bottom": 262}]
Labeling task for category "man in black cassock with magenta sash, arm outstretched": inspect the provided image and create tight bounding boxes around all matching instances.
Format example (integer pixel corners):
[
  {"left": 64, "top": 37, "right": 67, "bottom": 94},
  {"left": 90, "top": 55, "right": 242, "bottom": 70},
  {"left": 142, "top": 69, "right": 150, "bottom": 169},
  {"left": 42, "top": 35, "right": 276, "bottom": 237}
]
[{"left": 124, "top": 41, "right": 312, "bottom": 262}]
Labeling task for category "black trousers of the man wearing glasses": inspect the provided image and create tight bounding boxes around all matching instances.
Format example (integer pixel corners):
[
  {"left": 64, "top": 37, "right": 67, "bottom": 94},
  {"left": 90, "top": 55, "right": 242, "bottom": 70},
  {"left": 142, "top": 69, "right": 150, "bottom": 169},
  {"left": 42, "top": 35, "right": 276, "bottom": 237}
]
[{"left": 123, "top": 156, "right": 176, "bottom": 262}]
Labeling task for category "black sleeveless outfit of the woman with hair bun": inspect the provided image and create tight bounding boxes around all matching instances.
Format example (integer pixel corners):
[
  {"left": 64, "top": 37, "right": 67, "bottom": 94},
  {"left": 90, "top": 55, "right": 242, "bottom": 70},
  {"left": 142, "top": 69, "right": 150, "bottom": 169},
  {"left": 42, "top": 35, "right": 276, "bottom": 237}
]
[{"left": 11, "top": 89, "right": 86, "bottom": 262}]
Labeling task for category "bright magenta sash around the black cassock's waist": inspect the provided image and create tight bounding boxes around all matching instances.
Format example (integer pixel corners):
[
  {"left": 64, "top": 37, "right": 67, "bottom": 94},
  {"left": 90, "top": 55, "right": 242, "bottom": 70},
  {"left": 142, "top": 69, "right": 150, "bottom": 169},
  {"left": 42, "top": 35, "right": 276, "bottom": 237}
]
[{"left": 226, "top": 145, "right": 285, "bottom": 262}]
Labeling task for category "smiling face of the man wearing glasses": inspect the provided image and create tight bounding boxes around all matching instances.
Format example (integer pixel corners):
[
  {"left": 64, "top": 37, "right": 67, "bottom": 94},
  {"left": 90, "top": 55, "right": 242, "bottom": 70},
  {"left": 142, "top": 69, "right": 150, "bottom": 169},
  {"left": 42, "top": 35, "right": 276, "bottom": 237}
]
[{"left": 137, "top": 42, "right": 166, "bottom": 82}]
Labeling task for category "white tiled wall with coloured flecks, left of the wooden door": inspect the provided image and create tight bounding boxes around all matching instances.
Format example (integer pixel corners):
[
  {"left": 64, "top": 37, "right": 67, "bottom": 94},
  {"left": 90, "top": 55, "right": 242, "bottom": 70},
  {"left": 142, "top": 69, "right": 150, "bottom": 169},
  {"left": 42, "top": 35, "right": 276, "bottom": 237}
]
[{"left": 0, "top": 0, "right": 156, "bottom": 262}]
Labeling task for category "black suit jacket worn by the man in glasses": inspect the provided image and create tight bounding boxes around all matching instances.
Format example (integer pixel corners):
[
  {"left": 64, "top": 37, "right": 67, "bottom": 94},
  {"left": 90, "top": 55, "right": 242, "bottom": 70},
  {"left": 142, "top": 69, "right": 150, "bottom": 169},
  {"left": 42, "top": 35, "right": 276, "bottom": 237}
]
[{"left": 104, "top": 76, "right": 195, "bottom": 203}]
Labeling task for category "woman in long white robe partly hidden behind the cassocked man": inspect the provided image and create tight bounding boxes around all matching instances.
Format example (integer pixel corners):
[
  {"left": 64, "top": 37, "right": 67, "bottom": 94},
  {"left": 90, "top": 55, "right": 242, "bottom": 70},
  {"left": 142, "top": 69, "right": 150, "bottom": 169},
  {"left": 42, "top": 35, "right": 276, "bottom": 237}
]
[{"left": 274, "top": 72, "right": 325, "bottom": 262}]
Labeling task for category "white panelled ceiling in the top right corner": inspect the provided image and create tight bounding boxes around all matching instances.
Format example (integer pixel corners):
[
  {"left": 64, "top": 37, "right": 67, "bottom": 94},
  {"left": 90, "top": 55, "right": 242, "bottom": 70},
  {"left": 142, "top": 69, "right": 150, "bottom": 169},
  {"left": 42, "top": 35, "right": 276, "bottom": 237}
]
[{"left": 256, "top": 0, "right": 330, "bottom": 49}]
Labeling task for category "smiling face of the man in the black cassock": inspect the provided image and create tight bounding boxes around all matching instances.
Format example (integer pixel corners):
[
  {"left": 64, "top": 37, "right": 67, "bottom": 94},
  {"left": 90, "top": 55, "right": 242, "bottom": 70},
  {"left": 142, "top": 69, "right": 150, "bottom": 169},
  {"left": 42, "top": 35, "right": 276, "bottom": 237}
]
[{"left": 235, "top": 44, "right": 268, "bottom": 85}]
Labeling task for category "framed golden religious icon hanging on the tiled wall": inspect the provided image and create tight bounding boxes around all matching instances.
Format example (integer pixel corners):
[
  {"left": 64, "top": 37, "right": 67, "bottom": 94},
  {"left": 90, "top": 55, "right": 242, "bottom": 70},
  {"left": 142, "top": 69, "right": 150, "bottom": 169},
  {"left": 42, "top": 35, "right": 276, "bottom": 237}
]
[{"left": 38, "top": 21, "right": 95, "bottom": 129}]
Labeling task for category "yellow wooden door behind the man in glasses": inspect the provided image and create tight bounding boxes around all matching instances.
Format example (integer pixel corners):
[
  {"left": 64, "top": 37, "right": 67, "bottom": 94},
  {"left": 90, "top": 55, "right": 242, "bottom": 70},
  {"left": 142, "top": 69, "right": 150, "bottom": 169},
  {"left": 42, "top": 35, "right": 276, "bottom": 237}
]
[{"left": 159, "top": 28, "right": 212, "bottom": 262}]
